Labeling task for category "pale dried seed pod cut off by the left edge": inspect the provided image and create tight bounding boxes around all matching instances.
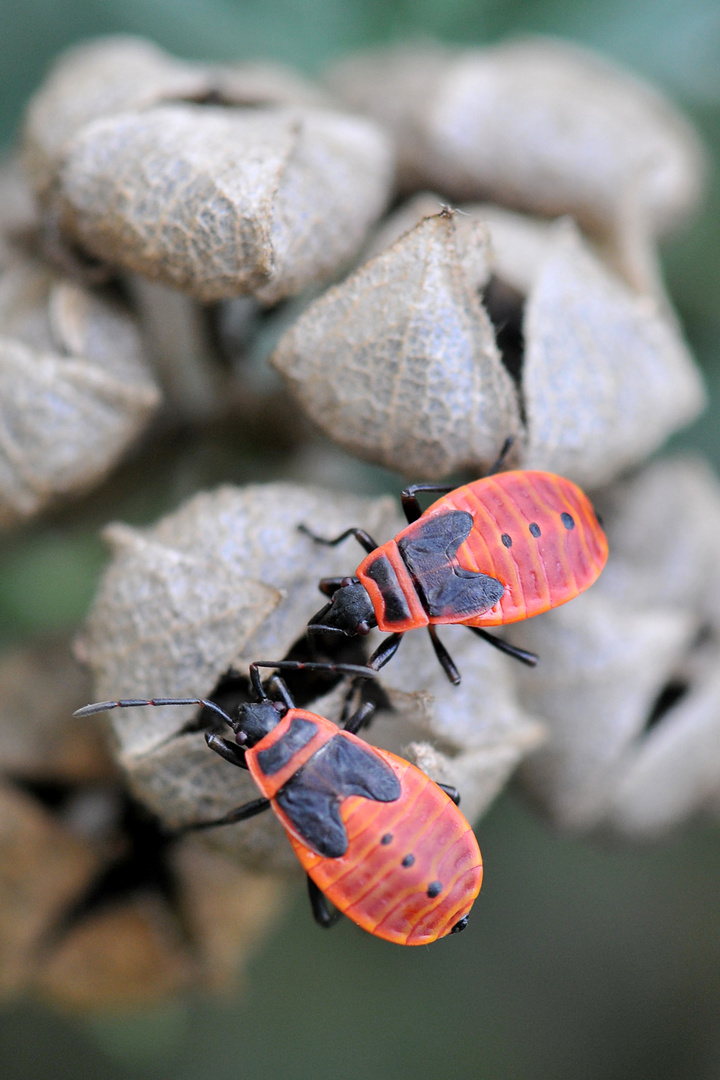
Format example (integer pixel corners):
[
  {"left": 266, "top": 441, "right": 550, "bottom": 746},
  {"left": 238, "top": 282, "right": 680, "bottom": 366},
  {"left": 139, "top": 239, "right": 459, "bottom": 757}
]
[{"left": 0, "top": 249, "right": 160, "bottom": 526}]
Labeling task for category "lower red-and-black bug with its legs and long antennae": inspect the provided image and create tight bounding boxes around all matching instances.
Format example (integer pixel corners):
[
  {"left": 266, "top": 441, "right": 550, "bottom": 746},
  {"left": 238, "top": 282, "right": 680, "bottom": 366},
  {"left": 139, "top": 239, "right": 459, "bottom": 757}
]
[{"left": 76, "top": 661, "right": 483, "bottom": 945}]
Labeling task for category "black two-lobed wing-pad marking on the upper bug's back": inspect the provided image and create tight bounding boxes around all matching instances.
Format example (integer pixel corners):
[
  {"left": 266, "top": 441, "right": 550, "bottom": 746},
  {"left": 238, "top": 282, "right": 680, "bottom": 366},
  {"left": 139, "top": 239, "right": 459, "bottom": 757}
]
[{"left": 397, "top": 510, "right": 505, "bottom": 621}]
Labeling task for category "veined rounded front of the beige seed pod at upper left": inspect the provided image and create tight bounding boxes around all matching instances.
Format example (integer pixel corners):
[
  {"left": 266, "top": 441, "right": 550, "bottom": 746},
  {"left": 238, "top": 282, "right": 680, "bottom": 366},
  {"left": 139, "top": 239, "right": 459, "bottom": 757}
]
[{"left": 58, "top": 105, "right": 392, "bottom": 303}]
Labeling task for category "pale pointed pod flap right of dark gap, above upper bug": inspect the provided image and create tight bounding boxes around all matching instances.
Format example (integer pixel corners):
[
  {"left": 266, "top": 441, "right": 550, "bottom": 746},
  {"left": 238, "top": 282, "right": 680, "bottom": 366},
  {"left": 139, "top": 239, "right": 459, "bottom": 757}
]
[{"left": 518, "top": 222, "right": 705, "bottom": 487}]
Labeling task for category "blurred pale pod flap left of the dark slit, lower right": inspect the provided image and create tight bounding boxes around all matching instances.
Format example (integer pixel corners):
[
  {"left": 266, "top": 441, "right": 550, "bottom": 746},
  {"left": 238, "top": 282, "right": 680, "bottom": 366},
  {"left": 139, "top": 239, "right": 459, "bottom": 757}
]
[{"left": 517, "top": 582, "right": 696, "bottom": 829}]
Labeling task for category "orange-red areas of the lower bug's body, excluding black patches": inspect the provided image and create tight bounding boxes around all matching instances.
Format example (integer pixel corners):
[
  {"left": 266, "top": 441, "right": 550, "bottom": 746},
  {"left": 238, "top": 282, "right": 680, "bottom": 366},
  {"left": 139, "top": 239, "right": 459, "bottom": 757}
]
[{"left": 245, "top": 708, "right": 483, "bottom": 945}]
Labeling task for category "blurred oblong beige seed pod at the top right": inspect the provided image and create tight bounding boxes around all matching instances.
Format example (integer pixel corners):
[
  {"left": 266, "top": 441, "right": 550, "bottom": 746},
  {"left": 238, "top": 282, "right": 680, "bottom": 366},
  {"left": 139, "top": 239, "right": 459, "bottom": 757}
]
[{"left": 330, "top": 39, "right": 705, "bottom": 234}]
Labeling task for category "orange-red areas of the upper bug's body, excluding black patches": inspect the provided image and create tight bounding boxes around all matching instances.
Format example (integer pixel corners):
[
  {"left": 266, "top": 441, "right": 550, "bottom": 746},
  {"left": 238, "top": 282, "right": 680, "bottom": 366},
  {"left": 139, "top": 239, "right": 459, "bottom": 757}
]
[{"left": 357, "top": 471, "right": 608, "bottom": 633}]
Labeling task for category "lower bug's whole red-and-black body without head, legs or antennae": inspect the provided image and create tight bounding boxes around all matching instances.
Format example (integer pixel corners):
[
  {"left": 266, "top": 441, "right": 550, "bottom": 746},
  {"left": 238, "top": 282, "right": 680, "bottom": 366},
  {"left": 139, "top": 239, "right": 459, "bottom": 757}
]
[{"left": 246, "top": 710, "right": 483, "bottom": 945}]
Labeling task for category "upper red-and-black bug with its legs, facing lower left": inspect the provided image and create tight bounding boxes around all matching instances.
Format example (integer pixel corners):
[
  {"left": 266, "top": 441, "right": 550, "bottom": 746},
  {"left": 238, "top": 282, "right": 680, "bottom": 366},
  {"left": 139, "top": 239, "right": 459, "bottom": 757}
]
[{"left": 300, "top": 453, "right": 608, "bottom": 684}]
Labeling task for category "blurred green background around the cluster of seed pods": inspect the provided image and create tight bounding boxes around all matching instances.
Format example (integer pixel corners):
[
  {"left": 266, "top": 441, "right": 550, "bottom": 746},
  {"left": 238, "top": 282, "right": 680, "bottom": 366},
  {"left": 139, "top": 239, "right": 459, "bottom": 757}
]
[{"left": 0, "top": 0, "right": 720, "bottom": 1080}]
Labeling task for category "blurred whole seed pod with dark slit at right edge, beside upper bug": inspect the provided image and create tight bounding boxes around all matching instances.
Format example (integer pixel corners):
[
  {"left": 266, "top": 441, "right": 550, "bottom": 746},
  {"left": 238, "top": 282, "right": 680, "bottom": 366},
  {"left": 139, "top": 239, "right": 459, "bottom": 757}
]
[{"left": 517, "top": 459, "right": 720, "bottom": 838}]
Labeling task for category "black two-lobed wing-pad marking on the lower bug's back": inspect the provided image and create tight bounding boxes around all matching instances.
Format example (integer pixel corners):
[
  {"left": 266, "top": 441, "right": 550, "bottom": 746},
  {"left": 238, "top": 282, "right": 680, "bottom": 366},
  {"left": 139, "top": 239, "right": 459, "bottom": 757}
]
[{"left": 275, "top": 731, "right": 402, "bottom": 859}]
